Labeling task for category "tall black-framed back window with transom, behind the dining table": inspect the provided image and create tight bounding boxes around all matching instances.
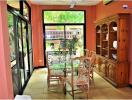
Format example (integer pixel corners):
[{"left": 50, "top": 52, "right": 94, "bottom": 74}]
[{"left": 43, "top": 11, "right": 85, "bottom": 67}]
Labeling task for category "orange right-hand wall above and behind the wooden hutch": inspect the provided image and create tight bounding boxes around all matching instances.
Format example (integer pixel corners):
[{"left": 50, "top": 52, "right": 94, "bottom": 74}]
[{"left": 96, "top": 0, "right": 132, "bottom": 84}]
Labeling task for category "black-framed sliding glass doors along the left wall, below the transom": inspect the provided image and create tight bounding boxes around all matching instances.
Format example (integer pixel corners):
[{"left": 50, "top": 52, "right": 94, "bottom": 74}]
[{"left": 8, "top": 8, "right": 33, "bottom": 96}]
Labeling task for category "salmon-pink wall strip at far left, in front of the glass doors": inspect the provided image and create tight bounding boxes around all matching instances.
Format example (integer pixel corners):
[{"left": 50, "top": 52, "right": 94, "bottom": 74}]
[{"left": 0, "top": 1, "right": 13, "bottom": 100}]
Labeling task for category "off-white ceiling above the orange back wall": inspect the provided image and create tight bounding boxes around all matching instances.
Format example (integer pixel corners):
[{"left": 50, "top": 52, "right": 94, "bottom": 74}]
[{"left": 30, "top": 0, "right": 102, "bottom": 6}]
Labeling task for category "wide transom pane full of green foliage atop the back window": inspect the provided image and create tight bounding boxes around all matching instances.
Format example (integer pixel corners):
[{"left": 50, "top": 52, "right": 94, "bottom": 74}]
[{"left": 44, "top": 11, "right": 84, "bottom": 23}]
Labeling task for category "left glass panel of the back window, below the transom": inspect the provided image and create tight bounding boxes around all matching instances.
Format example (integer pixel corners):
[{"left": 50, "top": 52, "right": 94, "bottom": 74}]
[{"left": 45, "top": 25, "right": 65, "bottom": 69}]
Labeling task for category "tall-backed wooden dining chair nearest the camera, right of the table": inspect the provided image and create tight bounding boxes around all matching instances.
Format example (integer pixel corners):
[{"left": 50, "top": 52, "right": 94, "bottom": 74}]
[{"left": 67, "top": 56, "right": 90, "bottom": 99}]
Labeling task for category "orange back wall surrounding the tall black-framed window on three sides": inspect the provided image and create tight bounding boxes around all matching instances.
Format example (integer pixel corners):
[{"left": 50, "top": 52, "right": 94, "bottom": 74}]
[{"left": 31, "top": 4, "right": 96, "bottom": 67}]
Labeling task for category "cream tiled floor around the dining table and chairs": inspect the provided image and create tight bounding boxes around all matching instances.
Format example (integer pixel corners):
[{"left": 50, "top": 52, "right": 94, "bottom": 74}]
[{"left": 24, "top": 68, "right": 132, "bottom": 100}]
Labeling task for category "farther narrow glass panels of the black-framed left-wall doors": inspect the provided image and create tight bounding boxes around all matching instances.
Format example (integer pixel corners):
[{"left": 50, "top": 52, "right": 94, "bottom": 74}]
[{"left": 17, "top": 18, "right": 30, "bottom": 86}]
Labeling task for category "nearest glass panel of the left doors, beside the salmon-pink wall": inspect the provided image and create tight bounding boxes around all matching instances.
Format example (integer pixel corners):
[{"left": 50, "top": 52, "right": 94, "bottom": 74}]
[{"left": 8, "top": 12, "right": 22, "bottom": 95}]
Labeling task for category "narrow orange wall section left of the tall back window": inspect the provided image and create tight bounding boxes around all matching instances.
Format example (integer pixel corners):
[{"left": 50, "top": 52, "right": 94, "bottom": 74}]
[{"left": 31, "top": 5, "right": 44, "bottom": 67}]
